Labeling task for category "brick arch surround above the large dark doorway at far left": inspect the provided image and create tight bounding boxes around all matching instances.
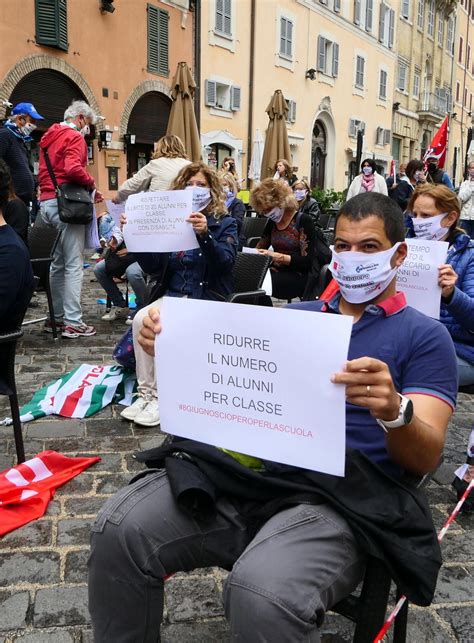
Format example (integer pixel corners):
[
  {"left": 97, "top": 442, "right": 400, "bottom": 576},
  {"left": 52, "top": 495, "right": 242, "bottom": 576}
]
[{"left": 0, "top": 54, "right": 104, "bottom": 129}]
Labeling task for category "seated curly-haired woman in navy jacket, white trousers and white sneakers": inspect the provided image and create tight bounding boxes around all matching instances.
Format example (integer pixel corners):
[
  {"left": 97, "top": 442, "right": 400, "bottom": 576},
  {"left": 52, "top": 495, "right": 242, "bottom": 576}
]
[{"left": 121, "top": 163, "right": 238, "bottom": 426}]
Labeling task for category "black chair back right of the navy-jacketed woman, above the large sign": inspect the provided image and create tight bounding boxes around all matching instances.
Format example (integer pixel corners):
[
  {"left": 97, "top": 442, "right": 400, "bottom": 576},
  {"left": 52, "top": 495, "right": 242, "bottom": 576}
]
[{"left": 226, "top": 252, "right": 271, "bottom": 304}]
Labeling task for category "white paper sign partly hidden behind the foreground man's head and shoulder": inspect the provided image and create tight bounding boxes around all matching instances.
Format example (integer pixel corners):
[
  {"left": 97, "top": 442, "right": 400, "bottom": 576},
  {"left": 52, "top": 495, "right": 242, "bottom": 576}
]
[{"left": 397, "top": 239, "right": 448, "bottom": 319}]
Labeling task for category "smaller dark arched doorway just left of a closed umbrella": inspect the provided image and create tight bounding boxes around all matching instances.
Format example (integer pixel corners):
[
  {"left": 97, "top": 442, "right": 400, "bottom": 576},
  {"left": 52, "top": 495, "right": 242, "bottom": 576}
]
[{"left": 127, "top": 92, "right": 171, "bottom": 177}]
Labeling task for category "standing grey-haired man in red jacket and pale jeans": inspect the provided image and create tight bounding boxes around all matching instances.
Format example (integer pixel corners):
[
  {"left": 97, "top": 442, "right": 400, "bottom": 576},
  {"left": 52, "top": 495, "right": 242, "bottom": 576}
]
[{"left": 39, "top": 101, "right": 102, "bottom": 338}]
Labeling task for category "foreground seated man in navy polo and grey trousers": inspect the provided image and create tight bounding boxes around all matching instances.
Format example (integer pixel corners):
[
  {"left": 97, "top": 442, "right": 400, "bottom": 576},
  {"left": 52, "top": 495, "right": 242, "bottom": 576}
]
[{"left": 89, "top": 193, "right": 457, "bottom": 643}]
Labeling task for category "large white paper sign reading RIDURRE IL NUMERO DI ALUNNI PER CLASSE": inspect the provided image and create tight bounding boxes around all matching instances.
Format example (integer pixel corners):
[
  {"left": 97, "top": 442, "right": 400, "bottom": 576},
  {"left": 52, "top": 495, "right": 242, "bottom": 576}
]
[{"left": 155, "top": 297, "right": 352, "bottom": 476}]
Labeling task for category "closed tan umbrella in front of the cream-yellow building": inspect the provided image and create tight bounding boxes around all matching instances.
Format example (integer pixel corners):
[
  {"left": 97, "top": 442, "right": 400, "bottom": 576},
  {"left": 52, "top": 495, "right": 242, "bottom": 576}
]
[{"left": 261, "top": 89, "right": 291, "bottom": 179}]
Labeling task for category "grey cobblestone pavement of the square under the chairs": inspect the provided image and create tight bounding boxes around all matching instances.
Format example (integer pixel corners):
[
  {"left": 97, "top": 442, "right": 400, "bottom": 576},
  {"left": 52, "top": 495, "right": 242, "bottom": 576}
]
[{"left": 0, "top": 268, "right": 474, "bottom": 643}]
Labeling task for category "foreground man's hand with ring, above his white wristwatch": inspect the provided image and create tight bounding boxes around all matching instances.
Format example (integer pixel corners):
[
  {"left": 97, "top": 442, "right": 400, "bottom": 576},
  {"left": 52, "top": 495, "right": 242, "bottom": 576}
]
[{"left": 331, "top": 357, "right": 400, "bottom": 422}]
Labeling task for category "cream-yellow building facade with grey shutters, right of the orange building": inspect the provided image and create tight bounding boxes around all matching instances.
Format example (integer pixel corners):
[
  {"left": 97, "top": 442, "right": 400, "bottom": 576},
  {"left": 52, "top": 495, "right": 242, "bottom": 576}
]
[{"left": 201, "top": 0, "right": 398, "bottom": 190}]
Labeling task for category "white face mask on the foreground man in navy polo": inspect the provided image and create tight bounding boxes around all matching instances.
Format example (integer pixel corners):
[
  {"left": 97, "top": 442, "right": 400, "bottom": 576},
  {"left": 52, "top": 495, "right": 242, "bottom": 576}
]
[{"left": 329, "top": 242, "right": 400, "bottom": 304}]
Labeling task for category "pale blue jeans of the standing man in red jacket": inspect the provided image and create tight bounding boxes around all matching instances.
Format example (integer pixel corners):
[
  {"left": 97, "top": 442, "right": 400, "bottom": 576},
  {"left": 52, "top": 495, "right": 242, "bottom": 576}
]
[{"left": 40, "top": 199, "right": 86, "bottom": 326}]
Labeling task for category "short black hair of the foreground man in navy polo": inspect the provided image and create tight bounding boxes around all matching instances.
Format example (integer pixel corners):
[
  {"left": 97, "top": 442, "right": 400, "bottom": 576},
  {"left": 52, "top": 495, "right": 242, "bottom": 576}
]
[{"left": 334, "top": 192, "right": 405, "bottom": 244}]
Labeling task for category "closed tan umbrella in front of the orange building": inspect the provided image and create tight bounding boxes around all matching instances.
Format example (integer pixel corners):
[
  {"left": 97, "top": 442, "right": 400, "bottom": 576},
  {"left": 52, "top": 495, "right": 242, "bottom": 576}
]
[{"left": 166, "top": 62, "right": 201, "bottom": 161}]
